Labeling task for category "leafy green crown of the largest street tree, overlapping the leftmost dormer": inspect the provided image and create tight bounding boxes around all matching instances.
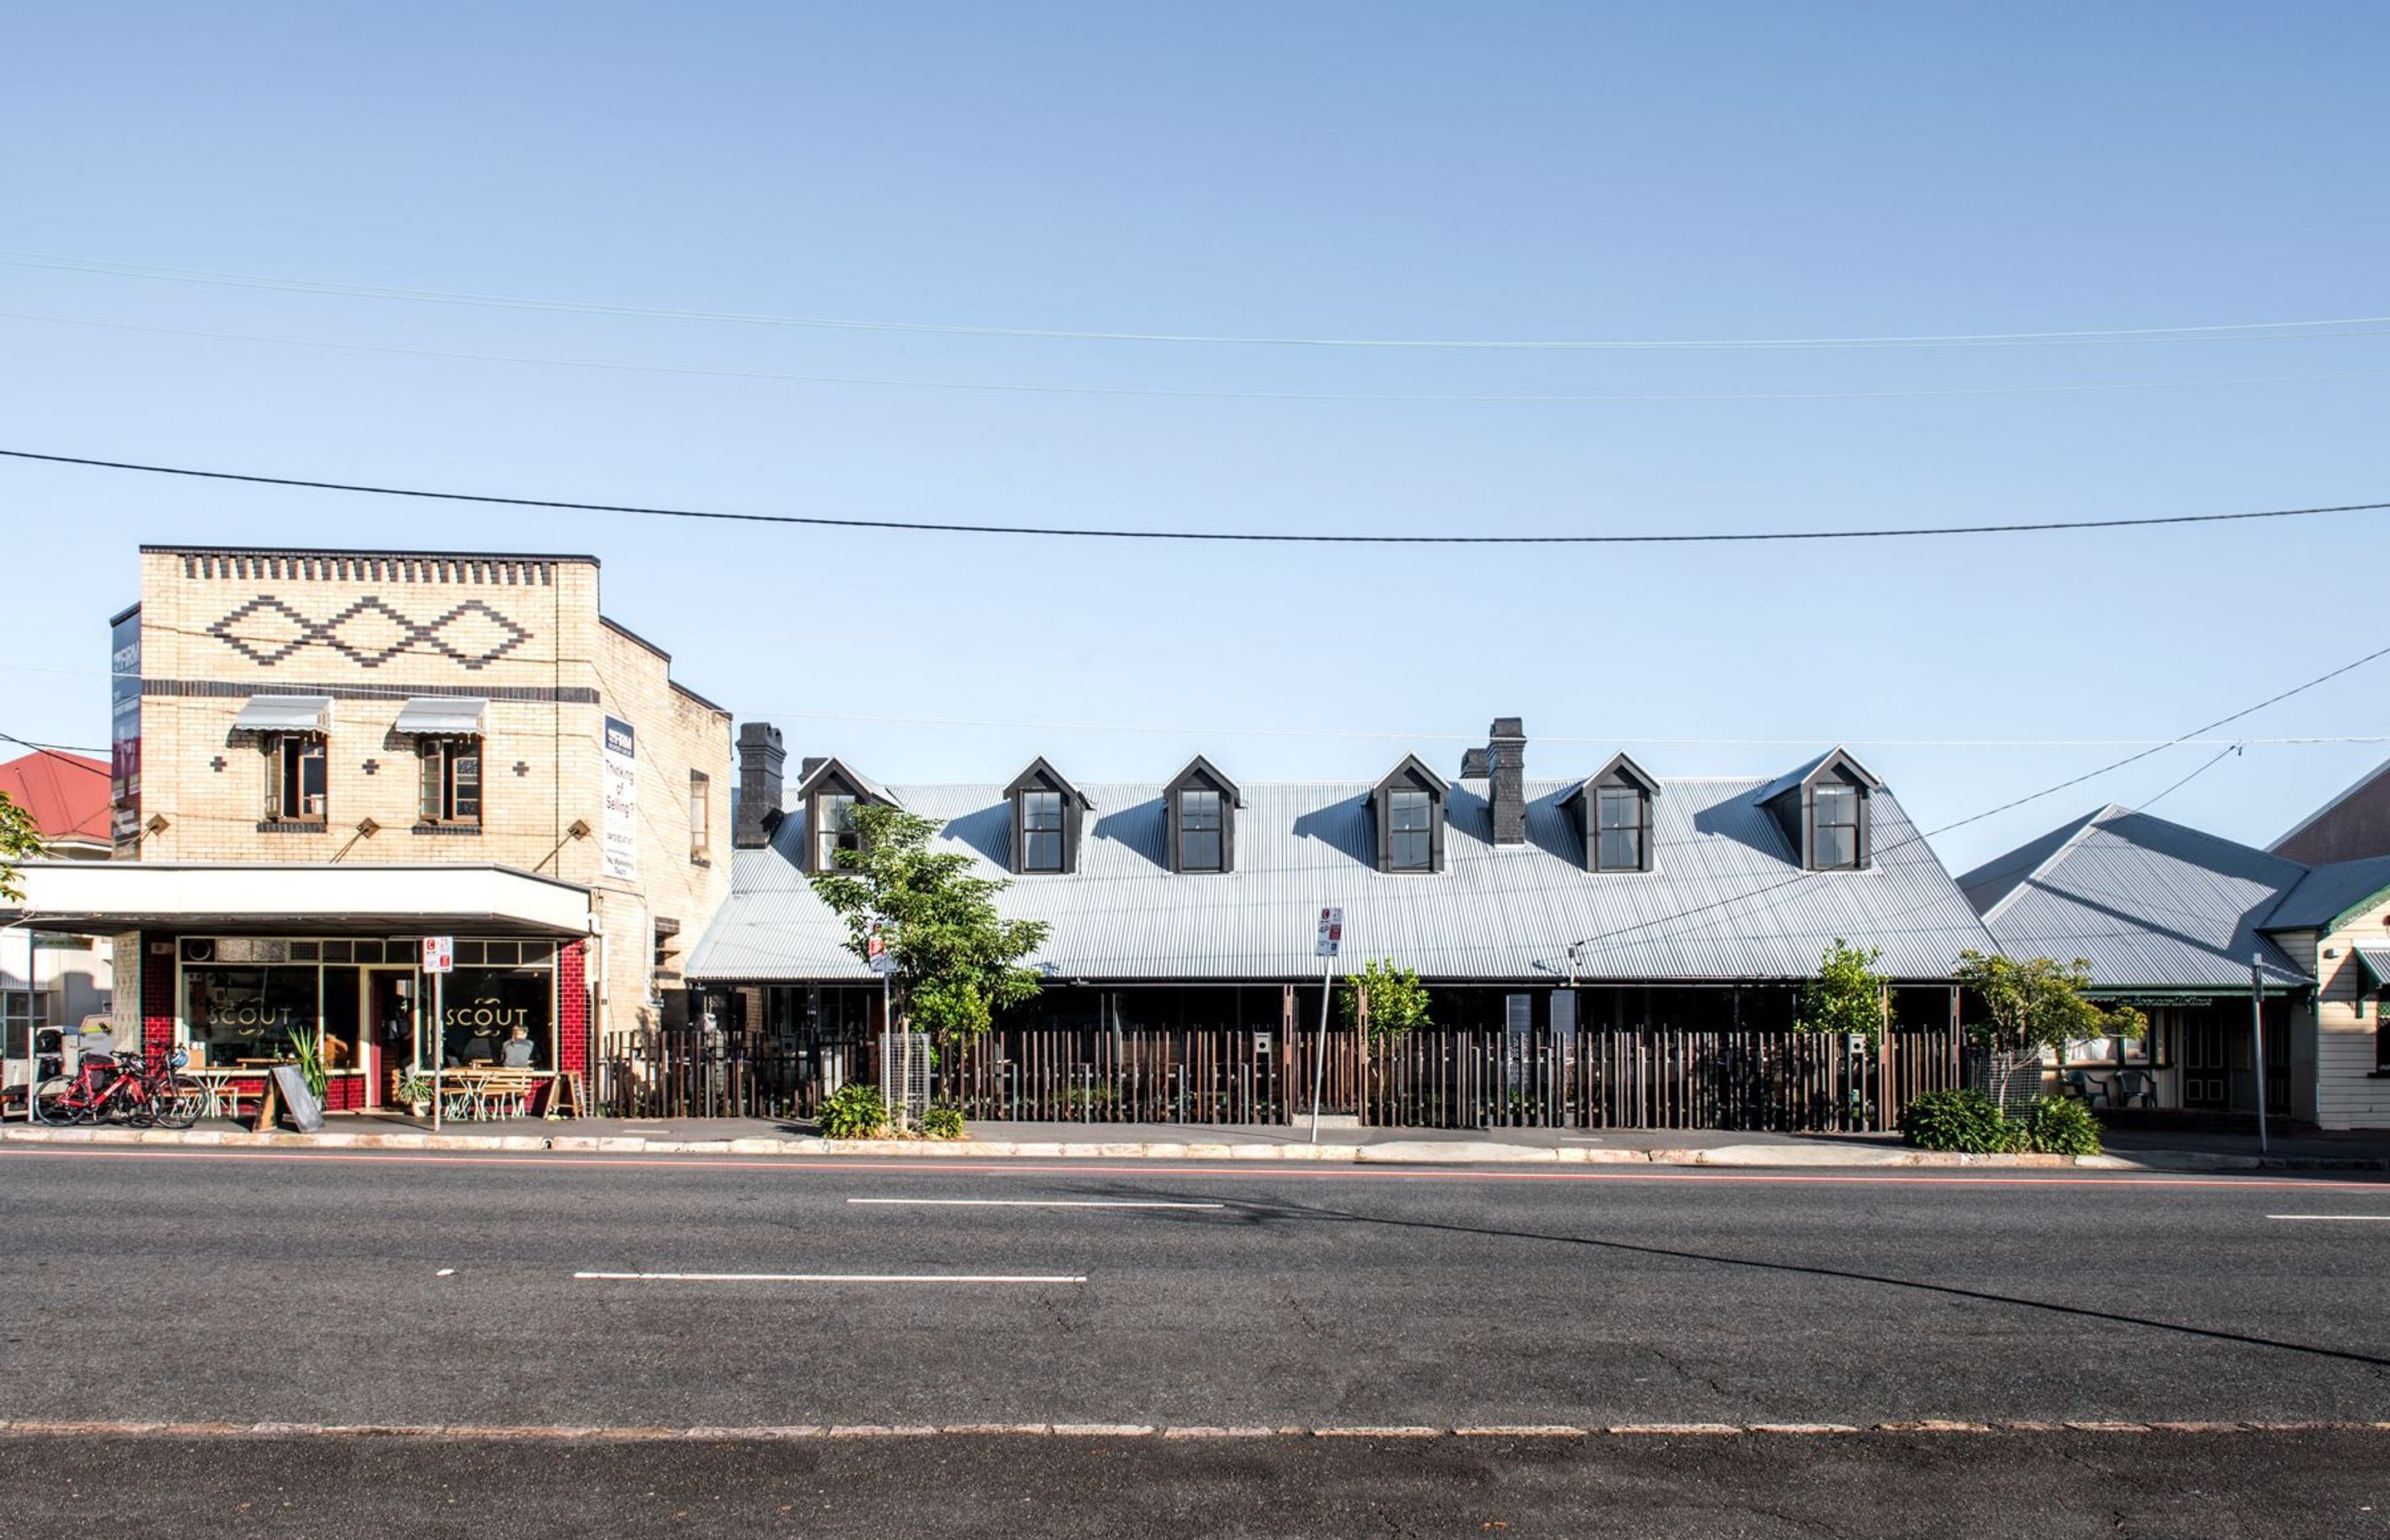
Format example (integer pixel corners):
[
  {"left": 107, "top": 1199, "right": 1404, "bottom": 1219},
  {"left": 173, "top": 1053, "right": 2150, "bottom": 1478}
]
[{"left": 812, "top": 806, "right": 1046, "bottom": 1060}]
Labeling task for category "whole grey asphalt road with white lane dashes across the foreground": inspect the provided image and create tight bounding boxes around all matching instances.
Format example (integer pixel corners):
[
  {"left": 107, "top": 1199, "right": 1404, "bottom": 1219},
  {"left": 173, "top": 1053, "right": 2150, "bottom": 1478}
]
[{"left": 0, "top": 1150, "right": 2390, "bottom": 1535}]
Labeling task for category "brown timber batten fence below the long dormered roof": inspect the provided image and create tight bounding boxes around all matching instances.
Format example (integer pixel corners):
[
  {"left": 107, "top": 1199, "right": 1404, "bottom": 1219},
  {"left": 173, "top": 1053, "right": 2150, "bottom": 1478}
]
[{"left": 595, "top": 1026, "right": 1962, "bottom": 1133}]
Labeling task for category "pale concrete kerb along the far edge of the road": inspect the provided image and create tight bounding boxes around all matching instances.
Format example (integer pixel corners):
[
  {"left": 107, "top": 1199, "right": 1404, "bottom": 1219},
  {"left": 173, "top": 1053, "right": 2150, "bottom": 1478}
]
[{"left": 0, "top": 1124, "right": 2361, "bottom": 1172}]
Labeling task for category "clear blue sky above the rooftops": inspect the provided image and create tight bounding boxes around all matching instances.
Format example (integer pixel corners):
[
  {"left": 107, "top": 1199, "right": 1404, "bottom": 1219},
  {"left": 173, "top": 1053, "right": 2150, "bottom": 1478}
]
[{"left": 0, "top": 2, "right": 2390, "bottom": 868}]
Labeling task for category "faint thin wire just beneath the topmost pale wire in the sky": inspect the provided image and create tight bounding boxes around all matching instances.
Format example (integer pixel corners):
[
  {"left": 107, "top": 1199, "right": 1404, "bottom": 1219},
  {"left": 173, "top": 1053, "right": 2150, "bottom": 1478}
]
[{"left": 13, "top": 311, "right": 2390, "bottom": 407}]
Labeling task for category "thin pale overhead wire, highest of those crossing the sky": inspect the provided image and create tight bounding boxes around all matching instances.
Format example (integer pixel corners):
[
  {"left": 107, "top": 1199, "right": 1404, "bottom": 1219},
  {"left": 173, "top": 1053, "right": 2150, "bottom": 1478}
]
[{"left": 13, "top": 251, "right": 2390, "bottom": 352}]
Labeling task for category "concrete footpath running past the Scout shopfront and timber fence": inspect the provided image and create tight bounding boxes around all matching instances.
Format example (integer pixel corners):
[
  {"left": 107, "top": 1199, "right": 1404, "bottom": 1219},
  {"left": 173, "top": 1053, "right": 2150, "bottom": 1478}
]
[{"left": 0, "top": 1114, "right": 2390, "bottom": 1172}]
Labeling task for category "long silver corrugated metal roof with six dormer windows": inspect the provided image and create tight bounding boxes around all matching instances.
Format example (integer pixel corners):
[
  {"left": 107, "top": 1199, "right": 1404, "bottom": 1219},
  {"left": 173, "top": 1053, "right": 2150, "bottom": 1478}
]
[{"left": 688, "top": 780, "right": 1991, "bottom": 982}]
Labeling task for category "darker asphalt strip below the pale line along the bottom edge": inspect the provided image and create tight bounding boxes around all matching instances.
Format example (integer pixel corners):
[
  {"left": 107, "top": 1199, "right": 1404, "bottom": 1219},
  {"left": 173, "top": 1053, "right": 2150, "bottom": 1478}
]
[{"left": 0, "top": 1432, "right": 2390, "bottom": 1540}]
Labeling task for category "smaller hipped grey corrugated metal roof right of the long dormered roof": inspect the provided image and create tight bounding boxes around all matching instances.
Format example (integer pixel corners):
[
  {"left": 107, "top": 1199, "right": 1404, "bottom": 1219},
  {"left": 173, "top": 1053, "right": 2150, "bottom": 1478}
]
[{"left": 1960, "top": 806, "right": 2311, "bottom": 990}]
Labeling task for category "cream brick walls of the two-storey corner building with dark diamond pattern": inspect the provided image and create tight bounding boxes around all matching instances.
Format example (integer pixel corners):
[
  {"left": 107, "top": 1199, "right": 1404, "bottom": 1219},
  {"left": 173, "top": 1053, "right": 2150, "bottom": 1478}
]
[{"left": 115, "top": 545, "right": 731, "bottom": 1060}]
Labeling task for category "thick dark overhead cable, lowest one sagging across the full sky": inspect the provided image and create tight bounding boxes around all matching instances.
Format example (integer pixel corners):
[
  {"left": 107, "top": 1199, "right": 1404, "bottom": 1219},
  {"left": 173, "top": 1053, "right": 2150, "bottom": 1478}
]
[{"left": 0, "top": 450, "right": 2390, "bottom": 545}]
